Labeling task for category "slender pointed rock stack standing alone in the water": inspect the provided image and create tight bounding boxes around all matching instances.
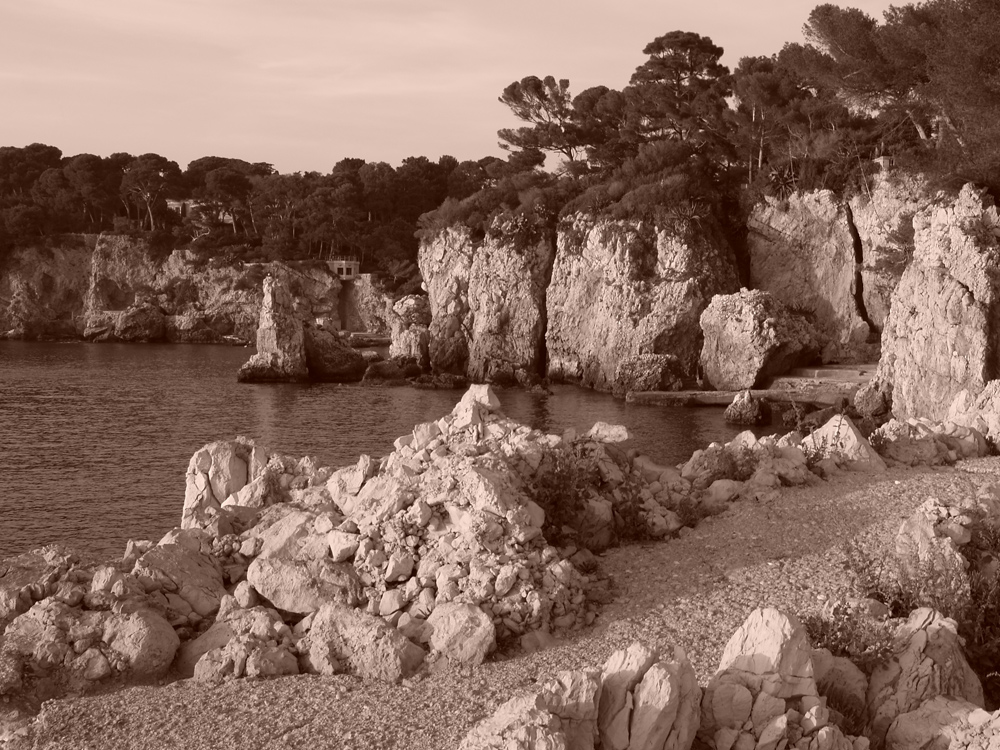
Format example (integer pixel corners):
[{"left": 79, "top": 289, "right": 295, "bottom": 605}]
[{"left": 236, "top": 275, "right": 309, "bottom": 383}]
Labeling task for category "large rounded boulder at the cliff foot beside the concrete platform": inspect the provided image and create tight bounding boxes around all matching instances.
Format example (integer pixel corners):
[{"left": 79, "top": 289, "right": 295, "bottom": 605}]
[{"left": 701, "top": 289, "right": 823, "bottom": 390}]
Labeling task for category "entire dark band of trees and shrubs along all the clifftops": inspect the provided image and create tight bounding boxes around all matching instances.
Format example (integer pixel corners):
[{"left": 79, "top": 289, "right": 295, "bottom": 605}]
[{"left": 0, "top": 0, "right": 1000, "bottom": 286}]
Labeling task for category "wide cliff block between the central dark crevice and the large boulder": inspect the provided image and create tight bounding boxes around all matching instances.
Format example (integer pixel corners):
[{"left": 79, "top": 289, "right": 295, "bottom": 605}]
[{"left": 545, "top": 216, "right": 738, "bottom": 390}]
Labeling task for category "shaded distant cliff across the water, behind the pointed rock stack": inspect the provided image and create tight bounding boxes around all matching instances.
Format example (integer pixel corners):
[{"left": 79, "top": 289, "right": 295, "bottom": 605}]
[{"left": 0, "top": 234, "right": 385, "bottom": 343}]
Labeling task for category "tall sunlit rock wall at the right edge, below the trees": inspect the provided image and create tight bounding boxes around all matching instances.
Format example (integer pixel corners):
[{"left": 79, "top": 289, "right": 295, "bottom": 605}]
[{"left": 861, "top": 185, "right": 1000, "bottom": 420}]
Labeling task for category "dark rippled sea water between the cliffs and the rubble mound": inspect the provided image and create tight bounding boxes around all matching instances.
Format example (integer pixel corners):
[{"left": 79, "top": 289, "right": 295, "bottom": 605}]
[{"left": 0, "top": 341, "right": 764, "bottom": 559}]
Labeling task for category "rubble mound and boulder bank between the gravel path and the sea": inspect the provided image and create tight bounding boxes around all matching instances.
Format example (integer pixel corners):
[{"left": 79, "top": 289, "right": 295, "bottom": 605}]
[{"left": 0, "top": 386, "right": 1000, "bottom": 747}]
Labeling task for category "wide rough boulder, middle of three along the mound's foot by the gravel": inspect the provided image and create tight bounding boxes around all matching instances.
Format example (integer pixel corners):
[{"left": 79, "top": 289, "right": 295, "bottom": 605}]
[{"left": 299, "top": 604, "right": 424, "bottom": 682}]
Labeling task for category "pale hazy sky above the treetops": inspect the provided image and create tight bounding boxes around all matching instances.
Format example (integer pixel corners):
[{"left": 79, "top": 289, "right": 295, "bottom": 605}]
[{"left": 0, "top": 0, "right": 903, "bottom": 173}]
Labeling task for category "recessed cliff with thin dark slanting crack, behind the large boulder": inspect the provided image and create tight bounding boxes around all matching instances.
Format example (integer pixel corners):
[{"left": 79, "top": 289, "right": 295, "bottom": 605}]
[{"left": 748, "top": 173, "right": 931, "bottom": 361}]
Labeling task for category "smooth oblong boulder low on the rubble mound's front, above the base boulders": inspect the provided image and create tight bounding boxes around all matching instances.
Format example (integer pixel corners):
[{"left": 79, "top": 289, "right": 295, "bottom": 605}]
[{"left": 247, "top": 557, "right": 364, "bottom": 614}]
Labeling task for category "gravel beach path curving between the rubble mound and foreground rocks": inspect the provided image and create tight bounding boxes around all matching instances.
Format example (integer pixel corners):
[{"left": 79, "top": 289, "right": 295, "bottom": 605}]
[{"left": 9, "top": 458, "right": 1000, "bottom": 750}]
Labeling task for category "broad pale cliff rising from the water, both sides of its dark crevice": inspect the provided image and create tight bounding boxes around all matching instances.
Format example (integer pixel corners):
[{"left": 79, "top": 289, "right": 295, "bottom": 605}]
[{"left": 420, "top": 216, "right": 739, "bottom": 390}]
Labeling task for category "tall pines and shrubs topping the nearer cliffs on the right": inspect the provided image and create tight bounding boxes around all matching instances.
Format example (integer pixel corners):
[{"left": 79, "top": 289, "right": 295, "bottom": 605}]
[{"left": 422, "top": 0, "right": 1000, "bottom": 250}]
